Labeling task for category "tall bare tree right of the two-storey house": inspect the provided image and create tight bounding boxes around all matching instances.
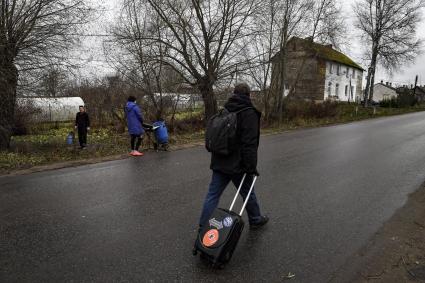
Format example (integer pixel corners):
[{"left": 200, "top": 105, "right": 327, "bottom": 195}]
[{"left": 354, "top": 0, "right": 425, "bottom": 106}]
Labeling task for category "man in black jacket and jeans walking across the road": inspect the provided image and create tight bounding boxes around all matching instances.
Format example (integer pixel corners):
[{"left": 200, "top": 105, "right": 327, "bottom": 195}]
[{"left": 200, "top": 83, "right": 269, "bottom": 229}]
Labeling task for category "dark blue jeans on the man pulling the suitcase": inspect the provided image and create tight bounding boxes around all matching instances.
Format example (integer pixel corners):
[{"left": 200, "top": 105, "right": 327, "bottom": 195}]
[{"left": 199, "top": 171, "right": 261, "bottom": 225}]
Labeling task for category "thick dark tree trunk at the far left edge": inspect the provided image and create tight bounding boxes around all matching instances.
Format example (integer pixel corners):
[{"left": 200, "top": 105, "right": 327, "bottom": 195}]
[{"left": 0, "top": 60, "right": 18, "bottom": 150}]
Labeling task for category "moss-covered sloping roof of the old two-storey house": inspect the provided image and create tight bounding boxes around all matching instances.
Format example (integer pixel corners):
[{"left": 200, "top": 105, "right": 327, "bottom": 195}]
[{"left": 273, "top": 37, "right": 364, "bottom": 71}]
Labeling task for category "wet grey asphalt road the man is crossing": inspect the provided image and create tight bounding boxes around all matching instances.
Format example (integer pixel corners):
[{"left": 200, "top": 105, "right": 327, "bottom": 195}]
[{"left": 0, "top": 113, "right": 425, "bottom": 282}]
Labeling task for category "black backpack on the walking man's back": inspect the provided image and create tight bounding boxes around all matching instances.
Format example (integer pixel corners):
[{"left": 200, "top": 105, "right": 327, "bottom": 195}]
[{"left": 205, "top": 107, "right": 253, "bottom": 155}]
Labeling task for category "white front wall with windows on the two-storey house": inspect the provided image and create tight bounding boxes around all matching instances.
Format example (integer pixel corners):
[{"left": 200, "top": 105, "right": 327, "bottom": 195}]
[{"left": 323, "top": 61, "right": 363, "bottom": 102}]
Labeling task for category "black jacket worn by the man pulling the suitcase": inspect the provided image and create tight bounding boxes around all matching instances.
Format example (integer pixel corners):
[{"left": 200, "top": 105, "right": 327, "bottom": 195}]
[{"left": 210, "top": 94, "right": 261, "bottom": 174}]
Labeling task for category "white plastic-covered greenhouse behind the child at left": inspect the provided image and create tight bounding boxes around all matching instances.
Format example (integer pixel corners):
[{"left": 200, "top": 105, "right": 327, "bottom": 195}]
[{"left": 17, "top": 97, "right": 84, "bottom": 122}]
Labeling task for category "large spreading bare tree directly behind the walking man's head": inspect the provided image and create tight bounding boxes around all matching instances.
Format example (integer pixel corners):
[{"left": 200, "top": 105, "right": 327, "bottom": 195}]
[{"left": 140, "top": 0, "right": 260, "bottom": 118}]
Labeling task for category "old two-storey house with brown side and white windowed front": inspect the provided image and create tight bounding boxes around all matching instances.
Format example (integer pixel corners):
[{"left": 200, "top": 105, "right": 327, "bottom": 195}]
[{"left": 271, "top": 37, "right": 364, "bottom": 101}]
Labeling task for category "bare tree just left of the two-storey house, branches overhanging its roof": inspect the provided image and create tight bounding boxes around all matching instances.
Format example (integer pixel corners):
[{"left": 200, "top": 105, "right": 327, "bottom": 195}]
[{"left": 234, "top": 0, "right": 345, "bottom": 124}]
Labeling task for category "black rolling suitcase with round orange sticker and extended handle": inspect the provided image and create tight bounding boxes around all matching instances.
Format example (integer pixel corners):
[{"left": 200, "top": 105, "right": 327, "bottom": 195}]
[{"left": 193, "top": 174, "right": 257, "bottom": 268}]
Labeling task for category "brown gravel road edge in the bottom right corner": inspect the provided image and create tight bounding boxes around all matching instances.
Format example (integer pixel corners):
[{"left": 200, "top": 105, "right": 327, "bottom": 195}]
[{"left": 329, "top": 183, "right": 425, "bottom": 283}]
